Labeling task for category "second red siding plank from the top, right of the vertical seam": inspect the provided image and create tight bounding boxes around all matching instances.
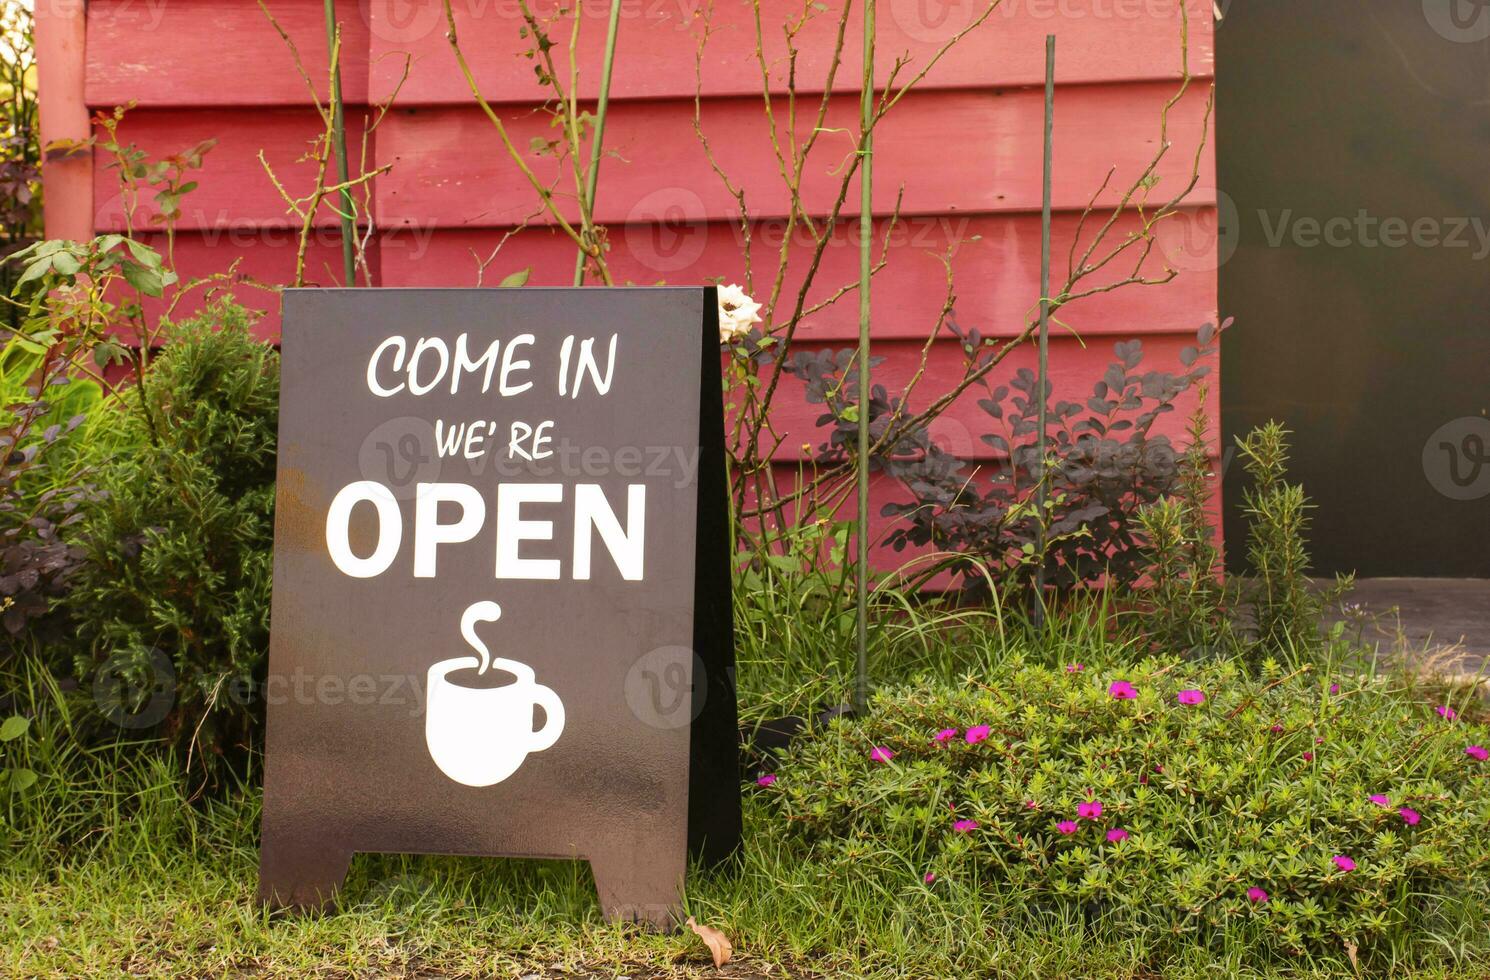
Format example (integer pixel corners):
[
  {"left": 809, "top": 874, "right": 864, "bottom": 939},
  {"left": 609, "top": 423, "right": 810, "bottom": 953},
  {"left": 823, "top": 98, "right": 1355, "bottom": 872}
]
[{"left": 377, "top": 83, "right": 1214, "bottom": 226}]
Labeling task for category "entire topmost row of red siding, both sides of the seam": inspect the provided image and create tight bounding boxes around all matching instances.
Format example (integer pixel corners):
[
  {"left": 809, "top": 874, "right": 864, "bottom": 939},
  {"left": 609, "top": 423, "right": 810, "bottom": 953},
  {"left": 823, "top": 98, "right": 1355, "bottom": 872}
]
[{"left": 86, "top": 0, "right": 1214, "bottom": 107}]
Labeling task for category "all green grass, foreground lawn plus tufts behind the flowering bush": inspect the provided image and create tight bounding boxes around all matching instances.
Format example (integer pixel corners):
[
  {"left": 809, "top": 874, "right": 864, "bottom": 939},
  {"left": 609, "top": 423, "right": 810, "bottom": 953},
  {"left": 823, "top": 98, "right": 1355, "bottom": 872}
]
[{"left": 0, "top": 585, "right": 1490, "bottom": 979}]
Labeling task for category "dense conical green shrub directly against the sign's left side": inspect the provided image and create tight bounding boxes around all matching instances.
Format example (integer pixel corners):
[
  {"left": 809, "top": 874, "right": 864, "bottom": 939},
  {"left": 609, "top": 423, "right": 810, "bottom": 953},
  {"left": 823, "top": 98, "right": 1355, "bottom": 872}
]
[{"left": 69, "top": 304, "right": 279, "bottom": 770}]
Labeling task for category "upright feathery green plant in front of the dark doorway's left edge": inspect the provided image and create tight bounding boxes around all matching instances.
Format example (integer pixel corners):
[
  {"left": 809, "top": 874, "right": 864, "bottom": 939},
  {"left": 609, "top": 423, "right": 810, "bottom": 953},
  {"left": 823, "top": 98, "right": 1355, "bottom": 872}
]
[{"left": 1237, "top": 421, "right": 1350, "bottom": 646}]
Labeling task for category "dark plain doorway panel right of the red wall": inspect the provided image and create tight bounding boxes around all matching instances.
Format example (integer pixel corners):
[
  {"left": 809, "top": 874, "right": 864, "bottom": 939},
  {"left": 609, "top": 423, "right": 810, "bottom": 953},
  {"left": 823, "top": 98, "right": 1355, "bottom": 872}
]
[{"left": 1216, "top": 0, "right": 1490, "bottom": 576}]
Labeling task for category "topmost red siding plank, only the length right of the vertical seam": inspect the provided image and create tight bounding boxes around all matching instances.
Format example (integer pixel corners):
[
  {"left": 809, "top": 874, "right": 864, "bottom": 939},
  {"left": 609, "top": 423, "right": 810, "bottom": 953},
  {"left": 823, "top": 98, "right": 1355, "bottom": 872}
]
[{"left": 370, "top": 0, "right": 1213, "bottom": 104}]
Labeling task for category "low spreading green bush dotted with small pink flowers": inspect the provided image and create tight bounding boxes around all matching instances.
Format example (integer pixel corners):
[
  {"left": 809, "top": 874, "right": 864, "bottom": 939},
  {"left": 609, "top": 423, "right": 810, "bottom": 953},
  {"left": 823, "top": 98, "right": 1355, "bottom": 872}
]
[{"left": 758, "top": 658, "right": 1490, "bottom": 961}]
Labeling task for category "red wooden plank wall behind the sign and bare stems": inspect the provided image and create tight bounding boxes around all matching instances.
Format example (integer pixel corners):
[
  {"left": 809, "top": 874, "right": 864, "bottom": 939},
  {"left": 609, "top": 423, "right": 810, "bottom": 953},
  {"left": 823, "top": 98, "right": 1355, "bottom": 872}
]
[{"left": 39, "top": 0, "right": 1219, "bottom": 560}]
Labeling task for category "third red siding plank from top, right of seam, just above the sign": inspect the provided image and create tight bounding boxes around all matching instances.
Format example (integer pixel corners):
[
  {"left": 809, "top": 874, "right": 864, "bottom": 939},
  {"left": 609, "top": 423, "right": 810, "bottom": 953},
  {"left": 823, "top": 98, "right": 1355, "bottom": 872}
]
[{"left": 380, "top": 209, "right": 1216, "bottom": 340}]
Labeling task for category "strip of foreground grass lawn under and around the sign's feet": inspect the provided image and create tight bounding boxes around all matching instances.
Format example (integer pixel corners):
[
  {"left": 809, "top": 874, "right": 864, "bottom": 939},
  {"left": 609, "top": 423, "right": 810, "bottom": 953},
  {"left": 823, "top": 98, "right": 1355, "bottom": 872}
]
[{"left": 0, "top": 804, "right": 1486, "bottom": 979}]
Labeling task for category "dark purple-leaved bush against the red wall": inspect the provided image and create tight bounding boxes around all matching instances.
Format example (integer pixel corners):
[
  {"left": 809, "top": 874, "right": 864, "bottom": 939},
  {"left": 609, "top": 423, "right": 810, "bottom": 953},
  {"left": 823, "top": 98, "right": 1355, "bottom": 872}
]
[{"left": 870, "top": 323, "right": 1217, "bottom": 591}]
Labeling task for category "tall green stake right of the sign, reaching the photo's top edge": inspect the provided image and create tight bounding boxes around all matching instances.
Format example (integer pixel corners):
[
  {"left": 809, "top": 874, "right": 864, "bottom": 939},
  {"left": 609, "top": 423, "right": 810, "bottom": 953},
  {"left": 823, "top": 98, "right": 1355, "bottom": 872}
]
[{"left": 854, "top": 0, "right": 875, "bottom": 713}]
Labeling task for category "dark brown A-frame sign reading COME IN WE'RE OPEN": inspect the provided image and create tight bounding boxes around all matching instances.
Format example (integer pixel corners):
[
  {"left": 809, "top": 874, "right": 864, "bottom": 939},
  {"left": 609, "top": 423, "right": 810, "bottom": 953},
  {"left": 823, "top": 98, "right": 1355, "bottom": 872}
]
[{"left": 259, "top": 287, "right": 741, "bottom": 925}]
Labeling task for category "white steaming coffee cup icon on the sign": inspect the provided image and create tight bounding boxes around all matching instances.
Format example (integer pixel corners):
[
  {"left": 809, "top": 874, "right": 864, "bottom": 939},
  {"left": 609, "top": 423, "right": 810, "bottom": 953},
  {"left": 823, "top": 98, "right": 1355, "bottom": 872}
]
[{"left": 425, "top": 602, "right": 563, "bottom": 786}]
